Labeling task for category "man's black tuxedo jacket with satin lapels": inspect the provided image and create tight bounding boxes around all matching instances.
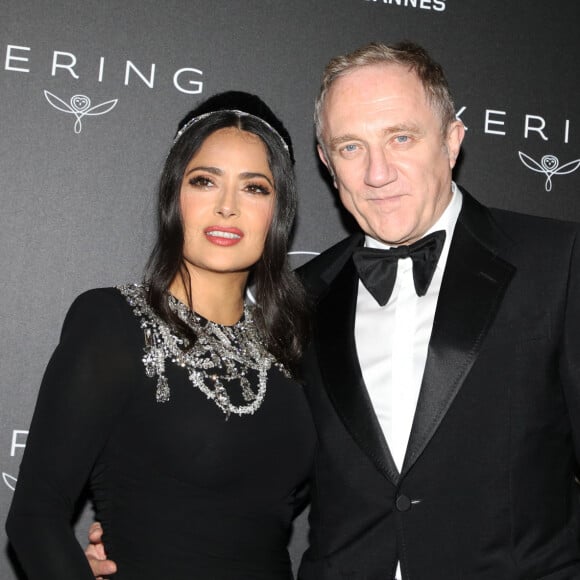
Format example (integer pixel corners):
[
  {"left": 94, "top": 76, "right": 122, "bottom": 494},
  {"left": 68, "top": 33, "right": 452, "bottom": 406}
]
[{"left": 300, "top": 192, "right": 580, "bottom": 580}]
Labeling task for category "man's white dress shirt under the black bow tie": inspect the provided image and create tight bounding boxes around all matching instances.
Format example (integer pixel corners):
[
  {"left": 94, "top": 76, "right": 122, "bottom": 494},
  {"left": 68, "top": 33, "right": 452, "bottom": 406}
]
[{"left": 355, "top": 183, "right": 462, "bottom": 580}]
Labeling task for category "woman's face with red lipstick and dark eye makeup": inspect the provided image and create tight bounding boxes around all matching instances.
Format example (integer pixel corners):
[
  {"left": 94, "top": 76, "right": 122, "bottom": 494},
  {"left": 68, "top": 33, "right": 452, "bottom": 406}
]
[{"left": 180, "top": 127, "right": 276, "bottom": 277}]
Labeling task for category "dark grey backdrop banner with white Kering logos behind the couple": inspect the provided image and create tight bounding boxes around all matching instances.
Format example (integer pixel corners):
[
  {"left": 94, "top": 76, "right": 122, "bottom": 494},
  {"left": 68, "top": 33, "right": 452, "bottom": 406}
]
[{"left": 0, "top": 0, "right": 580, "bottom": 580}]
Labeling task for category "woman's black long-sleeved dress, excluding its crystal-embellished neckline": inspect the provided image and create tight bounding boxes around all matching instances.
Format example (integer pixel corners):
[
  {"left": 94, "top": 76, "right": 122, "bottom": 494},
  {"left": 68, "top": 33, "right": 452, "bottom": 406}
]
[{"left": 7, "top": 288, "right": 315, "bottom": 580}]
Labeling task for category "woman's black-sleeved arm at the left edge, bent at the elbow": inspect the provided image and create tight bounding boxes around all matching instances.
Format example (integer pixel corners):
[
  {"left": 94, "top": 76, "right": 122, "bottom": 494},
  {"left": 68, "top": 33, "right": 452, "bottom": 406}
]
[{"left": 6, "top": 289, "right": 140, "bottom": 580}]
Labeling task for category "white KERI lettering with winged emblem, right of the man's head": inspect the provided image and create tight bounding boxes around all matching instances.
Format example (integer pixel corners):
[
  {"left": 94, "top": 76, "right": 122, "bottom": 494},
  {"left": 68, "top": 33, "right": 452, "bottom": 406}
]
[{"left": 456, "top": 106, "right": 580, "bottom": 191}]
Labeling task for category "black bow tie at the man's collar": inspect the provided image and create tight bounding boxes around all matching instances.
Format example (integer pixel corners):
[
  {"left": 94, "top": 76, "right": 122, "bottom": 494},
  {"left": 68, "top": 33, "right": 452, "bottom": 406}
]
[{"left": 352, "top": 230, "right": 445, "bottom": 306}]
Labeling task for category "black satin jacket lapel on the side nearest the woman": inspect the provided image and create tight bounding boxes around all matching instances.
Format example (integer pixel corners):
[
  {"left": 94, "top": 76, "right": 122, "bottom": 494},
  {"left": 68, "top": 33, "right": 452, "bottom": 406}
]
[{"left": 315, "top": 242, "right": 399, "bottom": 484}]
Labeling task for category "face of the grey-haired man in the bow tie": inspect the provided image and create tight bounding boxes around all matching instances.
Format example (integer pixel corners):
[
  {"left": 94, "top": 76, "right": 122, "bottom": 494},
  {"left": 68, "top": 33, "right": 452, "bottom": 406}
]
[{"left": 319, "top": 64, "right": 464, "bottom": 245}]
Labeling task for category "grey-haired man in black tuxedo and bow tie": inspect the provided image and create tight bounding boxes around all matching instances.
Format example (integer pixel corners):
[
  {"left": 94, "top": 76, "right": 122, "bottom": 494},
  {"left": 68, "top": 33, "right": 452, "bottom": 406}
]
[{"left": 87, "top": 43, "right": 580, "bottom": 580}]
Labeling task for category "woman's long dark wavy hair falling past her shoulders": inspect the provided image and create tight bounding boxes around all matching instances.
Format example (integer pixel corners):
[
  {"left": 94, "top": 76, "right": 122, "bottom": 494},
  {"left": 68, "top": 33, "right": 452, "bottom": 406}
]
[{"left": 145, "top": 92, "right": 308, "bottom": 372}]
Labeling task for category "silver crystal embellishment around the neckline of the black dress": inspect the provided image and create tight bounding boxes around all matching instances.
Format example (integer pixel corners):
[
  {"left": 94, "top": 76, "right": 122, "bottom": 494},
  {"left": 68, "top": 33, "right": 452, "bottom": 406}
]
[{"left": 117, "top": 284, "right": 290, "bottom": 418}]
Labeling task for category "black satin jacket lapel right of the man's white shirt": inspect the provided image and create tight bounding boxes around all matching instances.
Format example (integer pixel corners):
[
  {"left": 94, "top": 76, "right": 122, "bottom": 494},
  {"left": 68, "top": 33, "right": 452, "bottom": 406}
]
[{"left": 403, "top": 192, "right": 515, "bottom": 474}]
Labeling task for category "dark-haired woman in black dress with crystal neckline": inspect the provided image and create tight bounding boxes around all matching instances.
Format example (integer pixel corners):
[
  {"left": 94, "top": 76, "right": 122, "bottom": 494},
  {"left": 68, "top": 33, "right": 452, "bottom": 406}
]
[{"left": 7, "top": 93, "right": 314, "bottom": 580}]
